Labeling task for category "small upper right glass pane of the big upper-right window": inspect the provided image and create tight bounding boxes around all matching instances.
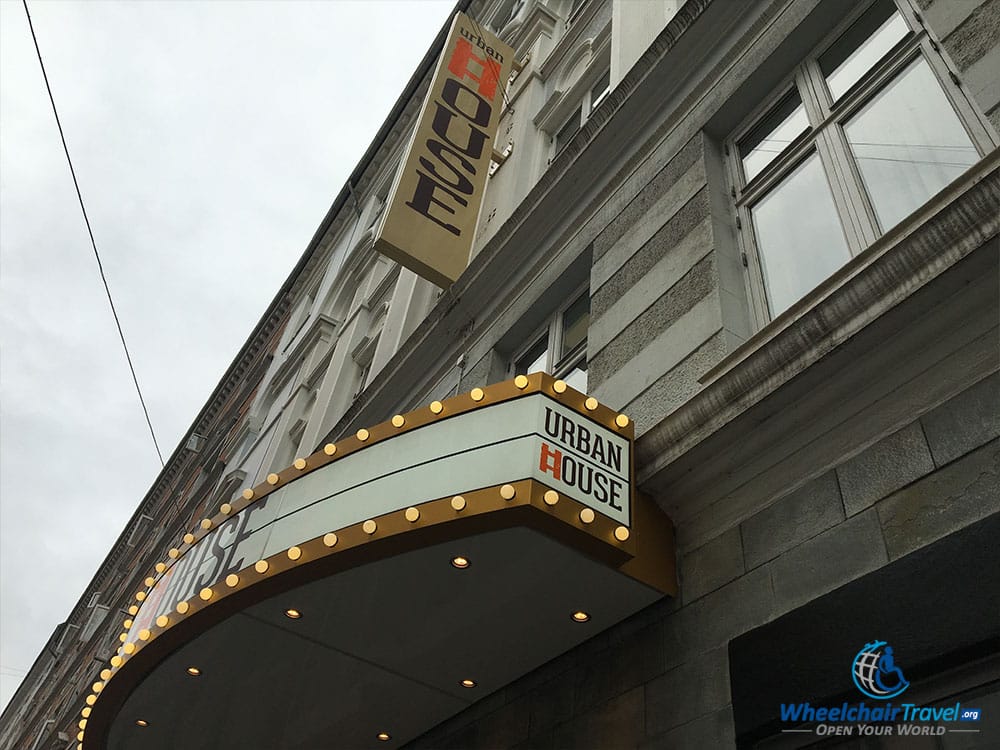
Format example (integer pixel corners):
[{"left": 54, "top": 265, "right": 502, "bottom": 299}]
[{"left": 819, "top": 0, "right": 910, "bottom": 101}]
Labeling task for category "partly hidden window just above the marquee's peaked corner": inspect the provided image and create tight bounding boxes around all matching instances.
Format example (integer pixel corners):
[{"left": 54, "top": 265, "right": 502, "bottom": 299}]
[{"left": 512, "top": 289, "right": 590, "bottom": 392}]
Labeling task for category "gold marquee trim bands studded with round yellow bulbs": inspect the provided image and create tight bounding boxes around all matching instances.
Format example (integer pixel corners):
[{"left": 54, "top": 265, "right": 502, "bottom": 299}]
[{"left": 77, "top": 373, "right": 676, "bottom": 750}]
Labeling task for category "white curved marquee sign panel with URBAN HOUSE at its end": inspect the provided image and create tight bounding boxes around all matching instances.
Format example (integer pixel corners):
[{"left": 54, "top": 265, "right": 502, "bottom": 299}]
[{"left": 128, "top": 393, "right": 632, "bottom": 641}]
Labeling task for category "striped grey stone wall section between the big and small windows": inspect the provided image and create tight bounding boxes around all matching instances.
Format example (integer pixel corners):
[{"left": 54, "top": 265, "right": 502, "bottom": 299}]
[{"left": 588, "top": 133, "right": 746, "bottom": 433}]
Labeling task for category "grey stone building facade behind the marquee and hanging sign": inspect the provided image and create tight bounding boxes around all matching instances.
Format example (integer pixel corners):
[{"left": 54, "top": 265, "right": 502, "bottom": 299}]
[{"left": 0, "top": 0, "right": 1000, "bottom": 750}]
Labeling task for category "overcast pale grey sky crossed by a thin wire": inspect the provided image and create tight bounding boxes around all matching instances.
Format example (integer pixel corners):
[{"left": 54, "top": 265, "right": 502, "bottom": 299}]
[{"left": 0, "top": 0, "right": 454, "bottom": 710}]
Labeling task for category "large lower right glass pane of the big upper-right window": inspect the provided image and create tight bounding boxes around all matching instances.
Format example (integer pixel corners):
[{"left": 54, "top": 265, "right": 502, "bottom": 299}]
[{"left": 844, "top": 58, "right": 979, "bottom": 231}]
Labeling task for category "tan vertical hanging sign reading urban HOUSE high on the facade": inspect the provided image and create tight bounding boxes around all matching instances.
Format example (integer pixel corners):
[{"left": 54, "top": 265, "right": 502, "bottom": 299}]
[{"left": 375, "top": 13, "right": 514, "bottom": 287}]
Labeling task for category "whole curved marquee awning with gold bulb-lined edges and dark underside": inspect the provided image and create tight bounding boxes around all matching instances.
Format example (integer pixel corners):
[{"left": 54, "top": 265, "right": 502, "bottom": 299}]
[{"left": 78, "top": 373, "right": 676, "bottom": 750}]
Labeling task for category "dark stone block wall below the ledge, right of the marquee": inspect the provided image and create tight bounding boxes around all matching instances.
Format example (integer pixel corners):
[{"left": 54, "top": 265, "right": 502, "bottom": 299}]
[{"left": 410, "top": 374, "right": 1000, "bottom": 750}]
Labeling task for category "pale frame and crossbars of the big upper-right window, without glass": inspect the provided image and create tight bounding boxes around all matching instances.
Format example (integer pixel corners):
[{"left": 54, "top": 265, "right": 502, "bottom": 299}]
[{"left": 725, "top": 0, "right": 996, "bottom": 330}]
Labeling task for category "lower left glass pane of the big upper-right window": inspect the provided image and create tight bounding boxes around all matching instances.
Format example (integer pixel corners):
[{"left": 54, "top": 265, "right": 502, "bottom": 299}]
[{"left": 751, "top": 153, "right": 850, "bottom": 315}]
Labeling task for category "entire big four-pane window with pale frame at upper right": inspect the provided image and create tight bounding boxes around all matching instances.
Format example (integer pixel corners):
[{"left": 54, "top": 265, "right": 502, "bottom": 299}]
[{"left": 726, "top": 0, "right": 995, "bottom": 327}]
